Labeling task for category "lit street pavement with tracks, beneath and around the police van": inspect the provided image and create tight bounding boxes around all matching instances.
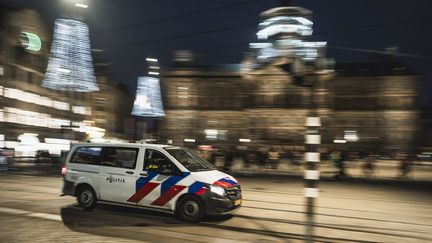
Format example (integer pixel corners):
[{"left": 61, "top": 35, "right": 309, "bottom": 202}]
[{"left": 0, "top": 172, "right": 432, "bottom": 242}]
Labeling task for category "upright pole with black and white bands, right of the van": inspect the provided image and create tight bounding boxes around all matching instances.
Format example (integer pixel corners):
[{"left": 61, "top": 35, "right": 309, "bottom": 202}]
[{"left": 304, "top": 77, "right": 321, "bottom": 242}]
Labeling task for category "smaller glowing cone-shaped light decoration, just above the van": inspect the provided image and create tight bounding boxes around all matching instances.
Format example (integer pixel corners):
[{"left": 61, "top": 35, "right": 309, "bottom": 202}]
[{"left": 131, "top": 76, "right": 165, "bottom": 117}]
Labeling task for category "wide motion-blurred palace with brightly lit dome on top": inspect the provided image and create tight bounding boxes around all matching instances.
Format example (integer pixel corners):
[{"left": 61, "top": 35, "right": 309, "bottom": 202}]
[{"left": 160, "top": 3, "right": 420, "bottom": 154}]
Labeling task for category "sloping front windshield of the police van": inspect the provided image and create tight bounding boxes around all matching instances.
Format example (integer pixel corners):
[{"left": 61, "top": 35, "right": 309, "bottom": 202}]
[{"left": 164, "top": 148, "right": 216, "bottom": 172}]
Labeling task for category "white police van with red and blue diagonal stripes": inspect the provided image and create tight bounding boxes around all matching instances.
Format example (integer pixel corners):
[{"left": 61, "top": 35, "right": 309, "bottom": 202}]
[{"left": 62, "top": 143, "right": 242, "bottom": 222}]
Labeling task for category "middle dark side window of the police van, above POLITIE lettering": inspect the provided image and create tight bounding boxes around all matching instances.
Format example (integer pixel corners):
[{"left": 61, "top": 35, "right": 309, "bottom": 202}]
[{"left": 101, "top": 147, "right": 138, "bottom": 169}]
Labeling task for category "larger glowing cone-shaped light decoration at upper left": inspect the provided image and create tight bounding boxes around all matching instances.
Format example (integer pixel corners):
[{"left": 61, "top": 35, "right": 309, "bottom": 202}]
[{"left": 42, "top": 19, "right": 99, "bottom": 92}]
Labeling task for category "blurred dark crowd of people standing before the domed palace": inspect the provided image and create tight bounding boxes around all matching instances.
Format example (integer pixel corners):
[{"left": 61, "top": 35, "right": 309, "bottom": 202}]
[{"left": 204, "top": 146, "right": 414, "bottom": 179}]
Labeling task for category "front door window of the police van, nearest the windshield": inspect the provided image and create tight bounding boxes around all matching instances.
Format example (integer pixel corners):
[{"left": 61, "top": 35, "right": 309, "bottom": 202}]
[{"left": 144, "top": 149, "right": 179, "bottom": 175}]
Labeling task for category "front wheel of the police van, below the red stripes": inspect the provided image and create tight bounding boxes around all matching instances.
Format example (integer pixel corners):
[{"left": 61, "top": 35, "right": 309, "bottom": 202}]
[{"left": 176, "top": 195, "right": 204, "bottom": 222}]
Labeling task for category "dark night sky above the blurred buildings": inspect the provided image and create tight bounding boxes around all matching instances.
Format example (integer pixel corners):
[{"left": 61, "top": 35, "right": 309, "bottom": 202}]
[{"left": 0, "top": 0, "right": 432, "bottom": 106}]
